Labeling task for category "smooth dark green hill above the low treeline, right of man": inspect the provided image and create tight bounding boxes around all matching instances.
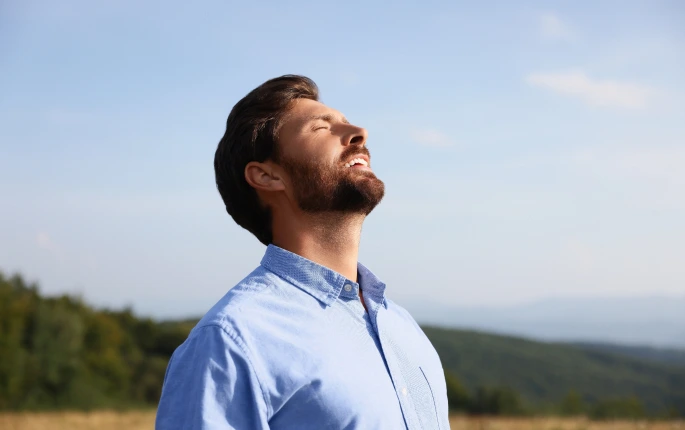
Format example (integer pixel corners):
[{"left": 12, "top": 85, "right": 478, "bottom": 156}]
[{"left": 424, "top": 327, "right": 685, "bottom": 414}]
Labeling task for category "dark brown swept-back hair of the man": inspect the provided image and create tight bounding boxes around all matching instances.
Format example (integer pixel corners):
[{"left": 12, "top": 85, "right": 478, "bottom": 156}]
[{"left": 214, "top": 75, "right": 319, "bottom": 245}]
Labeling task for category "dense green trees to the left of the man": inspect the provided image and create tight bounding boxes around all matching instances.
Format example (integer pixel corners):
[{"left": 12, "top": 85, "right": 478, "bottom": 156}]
[{"left": 0, "top": 273, "right": 189, "bottom": 410}]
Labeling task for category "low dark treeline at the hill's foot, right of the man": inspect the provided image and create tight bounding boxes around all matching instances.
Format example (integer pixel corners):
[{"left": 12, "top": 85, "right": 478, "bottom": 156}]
[{"left": 445, "top": 371, "right": 679, "bottom": 419}]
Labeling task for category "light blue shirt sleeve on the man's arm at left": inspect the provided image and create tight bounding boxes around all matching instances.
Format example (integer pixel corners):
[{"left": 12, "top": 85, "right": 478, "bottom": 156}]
[{"left": 155, "top": 325, "right": 269, "bottom": 430}]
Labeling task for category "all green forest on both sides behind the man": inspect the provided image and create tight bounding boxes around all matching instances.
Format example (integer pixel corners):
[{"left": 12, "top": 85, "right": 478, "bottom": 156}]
[{"left": 0, "top": 272, "right": 685, "bottom": 419}]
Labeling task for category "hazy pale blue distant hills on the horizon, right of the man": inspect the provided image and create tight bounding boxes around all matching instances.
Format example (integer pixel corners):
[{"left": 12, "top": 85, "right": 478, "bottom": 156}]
[{"left": 406, "top": 296, "right": 685, "bottom": 349}]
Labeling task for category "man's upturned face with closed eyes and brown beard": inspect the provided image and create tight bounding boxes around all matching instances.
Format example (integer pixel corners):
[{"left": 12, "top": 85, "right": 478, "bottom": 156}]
[{"left": 278, "top": 99, "right": 385, "bottom": 215}]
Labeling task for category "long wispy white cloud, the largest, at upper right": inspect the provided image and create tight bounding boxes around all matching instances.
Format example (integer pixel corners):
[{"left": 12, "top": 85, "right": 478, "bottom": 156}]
[{"left": 526, "top": 70, "right": 655, "bottom": 109}]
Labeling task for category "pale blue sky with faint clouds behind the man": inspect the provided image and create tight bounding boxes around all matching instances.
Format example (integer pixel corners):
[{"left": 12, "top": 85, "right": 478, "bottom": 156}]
[{"left": 0, "top": 0, "right": 685, "bottom": 318}]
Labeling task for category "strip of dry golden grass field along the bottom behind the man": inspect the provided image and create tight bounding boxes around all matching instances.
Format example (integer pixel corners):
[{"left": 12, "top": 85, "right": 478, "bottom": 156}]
[{"left": 0, "top": 411, "right": 685, "bottom": 430}]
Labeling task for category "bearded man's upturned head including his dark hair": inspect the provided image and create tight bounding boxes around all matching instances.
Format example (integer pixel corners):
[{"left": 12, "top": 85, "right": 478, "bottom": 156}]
[{"left": 214, "top": 75, "right": 384, "bottom": 244}]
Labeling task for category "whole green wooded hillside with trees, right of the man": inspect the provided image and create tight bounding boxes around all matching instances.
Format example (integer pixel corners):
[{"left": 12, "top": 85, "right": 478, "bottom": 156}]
[{"left": 423, "top": 327, "right": 685, "bottom": 418}]
